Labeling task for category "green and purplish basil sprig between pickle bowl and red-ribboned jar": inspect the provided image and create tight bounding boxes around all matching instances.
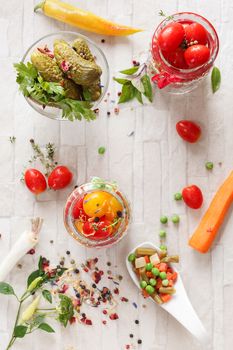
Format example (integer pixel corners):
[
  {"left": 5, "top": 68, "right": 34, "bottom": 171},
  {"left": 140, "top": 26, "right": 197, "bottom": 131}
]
[{"left": 113, "top": 63, "right": 153, "bottom": 104}]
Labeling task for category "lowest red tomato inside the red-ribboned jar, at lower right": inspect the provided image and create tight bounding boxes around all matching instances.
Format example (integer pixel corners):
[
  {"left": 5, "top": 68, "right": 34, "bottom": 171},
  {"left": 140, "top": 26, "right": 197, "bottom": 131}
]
[{"left": 184, "top": 45, "right": 210, "bottom": 68}]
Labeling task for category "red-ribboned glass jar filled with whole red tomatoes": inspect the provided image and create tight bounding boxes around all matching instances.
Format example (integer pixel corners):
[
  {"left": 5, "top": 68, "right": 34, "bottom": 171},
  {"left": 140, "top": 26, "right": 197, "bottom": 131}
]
[{"left": 151, "top": 12, "right": 219, "bottom": 94}]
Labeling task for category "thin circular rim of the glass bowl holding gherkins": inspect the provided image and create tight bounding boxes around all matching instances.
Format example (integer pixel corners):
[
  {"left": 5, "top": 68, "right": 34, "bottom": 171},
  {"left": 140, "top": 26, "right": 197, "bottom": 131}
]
[{"left": 21, "top": 30, "right": 110, "bottom": 121}]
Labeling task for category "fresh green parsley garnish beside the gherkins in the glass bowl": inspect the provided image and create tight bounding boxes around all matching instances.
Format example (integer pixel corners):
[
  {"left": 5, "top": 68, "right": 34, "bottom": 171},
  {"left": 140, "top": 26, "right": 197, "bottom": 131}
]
[{"left": 14, "top": 62, "right": 96, "bottom": 121}]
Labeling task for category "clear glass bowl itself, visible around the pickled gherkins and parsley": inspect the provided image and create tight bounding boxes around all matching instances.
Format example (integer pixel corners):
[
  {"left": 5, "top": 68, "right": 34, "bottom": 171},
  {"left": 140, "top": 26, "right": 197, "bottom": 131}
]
[{"left": 22, "top": 31, "right": 109, "bottom": 120}]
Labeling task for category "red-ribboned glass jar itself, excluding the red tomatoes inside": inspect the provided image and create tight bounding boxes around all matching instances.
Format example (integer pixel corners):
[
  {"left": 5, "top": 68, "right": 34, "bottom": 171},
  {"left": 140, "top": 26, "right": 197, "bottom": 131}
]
[{"left": 150, "top": 12, "right": 219, "bottom": 94}]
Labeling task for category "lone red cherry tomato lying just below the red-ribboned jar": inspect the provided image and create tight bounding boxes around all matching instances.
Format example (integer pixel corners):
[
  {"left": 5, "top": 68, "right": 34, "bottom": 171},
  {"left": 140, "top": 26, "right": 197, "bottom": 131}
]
[{"left": 176, "top": 120, "right": 201, "bottom": 143}]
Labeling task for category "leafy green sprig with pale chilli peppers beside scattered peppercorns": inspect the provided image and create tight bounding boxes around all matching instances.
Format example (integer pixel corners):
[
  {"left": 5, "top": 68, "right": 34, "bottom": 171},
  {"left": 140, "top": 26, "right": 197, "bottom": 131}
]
[{"left": 0, "top": 257, "right": 74, "bottom": 350}]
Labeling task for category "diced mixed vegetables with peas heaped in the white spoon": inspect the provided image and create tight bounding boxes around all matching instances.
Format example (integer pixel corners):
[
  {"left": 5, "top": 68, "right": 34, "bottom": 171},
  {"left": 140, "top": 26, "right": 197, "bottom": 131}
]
[{"left": 128, "top": 247, "right": 179, "bottom": 304}]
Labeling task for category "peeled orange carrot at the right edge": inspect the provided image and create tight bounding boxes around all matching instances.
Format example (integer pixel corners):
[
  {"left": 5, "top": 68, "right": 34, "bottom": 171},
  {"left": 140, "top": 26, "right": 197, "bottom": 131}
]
[{"left": 189, "top": 171, "right": 233, "bottom": 253}]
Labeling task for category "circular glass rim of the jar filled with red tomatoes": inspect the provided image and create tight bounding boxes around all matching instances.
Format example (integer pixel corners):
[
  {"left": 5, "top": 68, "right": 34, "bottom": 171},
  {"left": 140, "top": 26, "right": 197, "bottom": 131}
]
[{"left": 152, "top": 11, "right": 219, "bottom": 75}]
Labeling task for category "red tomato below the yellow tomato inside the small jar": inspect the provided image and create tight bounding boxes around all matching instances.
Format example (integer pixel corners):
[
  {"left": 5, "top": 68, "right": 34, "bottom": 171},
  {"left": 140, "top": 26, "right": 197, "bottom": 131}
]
[{"left": 83, "top": 219, "right": 112, "bottom": 240}]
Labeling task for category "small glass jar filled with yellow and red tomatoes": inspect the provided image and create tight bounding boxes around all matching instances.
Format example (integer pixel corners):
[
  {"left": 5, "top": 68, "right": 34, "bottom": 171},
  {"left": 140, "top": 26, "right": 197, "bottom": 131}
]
[{"left": 64, "top": 178, "right": 130, "bottom": 248}]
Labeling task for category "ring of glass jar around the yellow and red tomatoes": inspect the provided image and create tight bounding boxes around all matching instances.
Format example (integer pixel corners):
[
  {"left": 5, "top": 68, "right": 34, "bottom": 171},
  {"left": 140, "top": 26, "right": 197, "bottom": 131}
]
[{"left": 64, "top": 178, "right": 130, "bottom": 248}]
